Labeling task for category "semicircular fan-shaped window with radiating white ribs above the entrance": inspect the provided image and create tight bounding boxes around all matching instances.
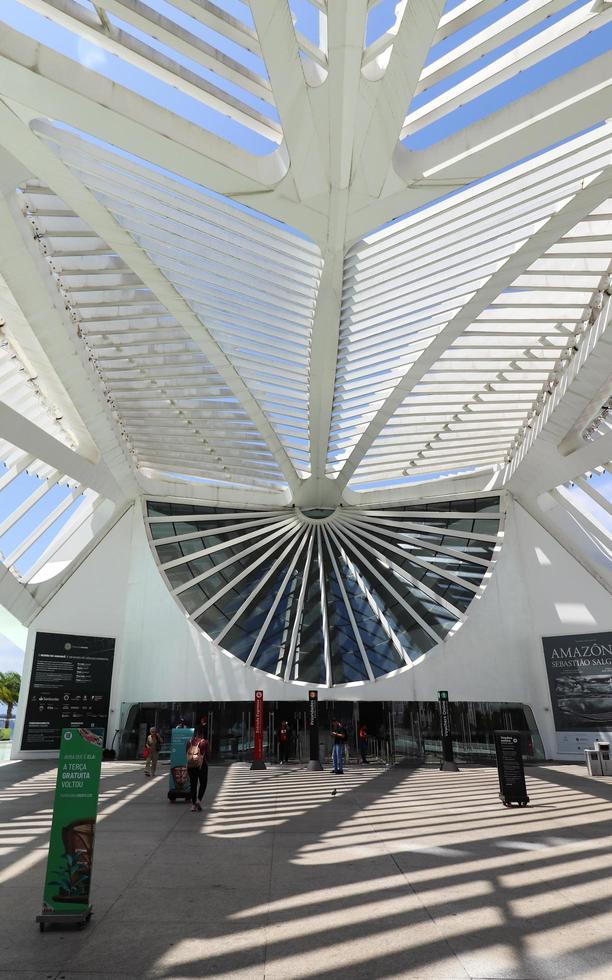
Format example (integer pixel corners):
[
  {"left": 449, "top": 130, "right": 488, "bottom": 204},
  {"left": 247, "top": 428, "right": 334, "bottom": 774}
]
[{"left": 147, "top": 496, "right": 503, "bottom": 687}]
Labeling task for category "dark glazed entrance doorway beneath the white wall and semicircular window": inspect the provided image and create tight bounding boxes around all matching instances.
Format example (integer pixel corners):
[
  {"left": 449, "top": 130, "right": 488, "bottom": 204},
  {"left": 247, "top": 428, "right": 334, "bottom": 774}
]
[{"left": 119, "top": 699, "right": 544, "bottom": 765}]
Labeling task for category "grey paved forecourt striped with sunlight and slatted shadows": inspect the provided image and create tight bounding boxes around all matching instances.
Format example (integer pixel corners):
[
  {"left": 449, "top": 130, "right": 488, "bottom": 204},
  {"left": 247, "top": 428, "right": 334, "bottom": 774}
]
[{"left": 0, "top": 762, "right": 612, "bottom": 980}]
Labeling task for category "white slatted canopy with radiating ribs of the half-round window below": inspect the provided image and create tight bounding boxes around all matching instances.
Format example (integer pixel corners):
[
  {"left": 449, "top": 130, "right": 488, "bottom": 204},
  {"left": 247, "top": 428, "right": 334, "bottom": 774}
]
[{"left": 0, "top": 0, "right": 612, "bottom": 685}]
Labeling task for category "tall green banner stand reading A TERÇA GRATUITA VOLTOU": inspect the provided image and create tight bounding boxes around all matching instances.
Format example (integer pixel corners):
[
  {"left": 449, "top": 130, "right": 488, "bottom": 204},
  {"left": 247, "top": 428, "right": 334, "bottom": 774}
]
[{"left": 36, "top": 728, "right": 102, "bottom": 932}]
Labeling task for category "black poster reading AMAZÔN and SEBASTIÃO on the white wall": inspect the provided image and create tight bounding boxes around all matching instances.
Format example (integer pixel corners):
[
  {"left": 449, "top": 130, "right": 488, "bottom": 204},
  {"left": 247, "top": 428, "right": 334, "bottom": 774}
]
[{"left": 542, "top": 633, "right": 612, "bottom": 732}]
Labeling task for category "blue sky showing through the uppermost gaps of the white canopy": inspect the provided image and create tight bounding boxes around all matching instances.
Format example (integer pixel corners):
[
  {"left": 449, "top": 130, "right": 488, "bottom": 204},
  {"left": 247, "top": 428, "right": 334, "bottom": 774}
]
[{"left": 5, "top": 0, "right": 612, "bottom": 154}]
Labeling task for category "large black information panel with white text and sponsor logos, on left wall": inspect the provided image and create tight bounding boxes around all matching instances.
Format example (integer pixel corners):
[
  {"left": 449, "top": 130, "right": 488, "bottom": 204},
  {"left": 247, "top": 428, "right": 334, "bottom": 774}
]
[{"left": 21, "top": 633, "right": 115, "bottom": 750}]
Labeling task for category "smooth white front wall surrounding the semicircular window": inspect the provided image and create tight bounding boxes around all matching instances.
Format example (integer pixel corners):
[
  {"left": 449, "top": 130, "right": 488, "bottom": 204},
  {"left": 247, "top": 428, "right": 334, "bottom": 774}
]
[{"left": 13, "top": 501, "right": 612, "bottom": 757}]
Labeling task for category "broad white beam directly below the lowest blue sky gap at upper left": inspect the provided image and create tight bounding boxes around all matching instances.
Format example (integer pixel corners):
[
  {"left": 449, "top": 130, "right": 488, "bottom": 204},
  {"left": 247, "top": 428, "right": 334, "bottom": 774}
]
[{"left": 0, "top": 25, "right": 325, "bottom": 238}]
